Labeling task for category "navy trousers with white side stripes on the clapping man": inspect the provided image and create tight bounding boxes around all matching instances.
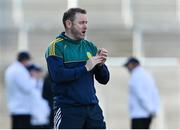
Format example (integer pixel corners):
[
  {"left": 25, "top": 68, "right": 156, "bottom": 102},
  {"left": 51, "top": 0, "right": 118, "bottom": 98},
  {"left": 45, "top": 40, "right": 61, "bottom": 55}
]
[{"left": 54, "top": 104, "right": 106, "bottom": 129}]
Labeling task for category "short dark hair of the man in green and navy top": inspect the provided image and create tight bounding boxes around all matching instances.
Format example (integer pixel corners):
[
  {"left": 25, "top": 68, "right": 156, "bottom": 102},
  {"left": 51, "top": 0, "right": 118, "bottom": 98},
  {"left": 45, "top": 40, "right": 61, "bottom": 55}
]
[{"left": 62, "top": 8, "right": 87, "bottom": 28}]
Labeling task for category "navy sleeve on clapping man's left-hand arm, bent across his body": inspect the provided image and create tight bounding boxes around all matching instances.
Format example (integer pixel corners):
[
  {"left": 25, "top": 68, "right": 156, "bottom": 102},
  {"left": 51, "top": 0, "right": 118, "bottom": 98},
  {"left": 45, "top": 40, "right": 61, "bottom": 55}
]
[{"left": 46, "top": 56, "right": 87, "bottom": 83}]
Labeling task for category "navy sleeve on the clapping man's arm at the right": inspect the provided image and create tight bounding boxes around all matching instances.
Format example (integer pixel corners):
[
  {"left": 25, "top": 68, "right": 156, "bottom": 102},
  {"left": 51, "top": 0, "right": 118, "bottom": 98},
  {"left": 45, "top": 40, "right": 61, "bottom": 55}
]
[{"left": 94, "top": 65, "right": 110, "bottom": 84}]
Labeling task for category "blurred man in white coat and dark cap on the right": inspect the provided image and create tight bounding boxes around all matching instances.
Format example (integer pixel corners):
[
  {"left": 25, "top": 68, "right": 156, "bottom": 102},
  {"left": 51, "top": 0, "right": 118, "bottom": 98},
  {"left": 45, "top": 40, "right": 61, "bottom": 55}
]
[{"left": 124, "top": 57, "right": 159, "bottom": 129}]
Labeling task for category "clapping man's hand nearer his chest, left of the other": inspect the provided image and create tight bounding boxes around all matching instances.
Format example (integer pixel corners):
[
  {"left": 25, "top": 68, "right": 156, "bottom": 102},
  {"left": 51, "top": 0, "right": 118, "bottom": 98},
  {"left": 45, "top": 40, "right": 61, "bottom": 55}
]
[{"left": 85, "top": 55, "right": 103, "bottom": 71}]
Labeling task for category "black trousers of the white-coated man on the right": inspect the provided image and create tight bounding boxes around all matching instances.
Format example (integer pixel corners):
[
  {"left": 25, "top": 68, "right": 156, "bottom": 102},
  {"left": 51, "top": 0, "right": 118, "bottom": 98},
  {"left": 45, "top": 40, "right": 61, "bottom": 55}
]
[{"left": 131, "top": 117, "right": 152, "bottom": 129}]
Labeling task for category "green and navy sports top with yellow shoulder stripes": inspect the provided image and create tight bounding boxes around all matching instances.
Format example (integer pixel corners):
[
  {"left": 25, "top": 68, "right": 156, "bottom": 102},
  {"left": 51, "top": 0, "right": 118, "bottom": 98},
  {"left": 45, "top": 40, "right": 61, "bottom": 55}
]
[{"left": 45, "top": 32, "right": 109, "bottom": 128}]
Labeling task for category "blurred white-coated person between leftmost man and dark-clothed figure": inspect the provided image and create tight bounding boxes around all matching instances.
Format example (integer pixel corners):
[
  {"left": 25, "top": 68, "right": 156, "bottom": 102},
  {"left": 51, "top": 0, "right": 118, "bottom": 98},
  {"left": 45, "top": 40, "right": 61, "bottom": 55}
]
[{"left": 27, "top": 64, "right": 50, "bottom": 129}]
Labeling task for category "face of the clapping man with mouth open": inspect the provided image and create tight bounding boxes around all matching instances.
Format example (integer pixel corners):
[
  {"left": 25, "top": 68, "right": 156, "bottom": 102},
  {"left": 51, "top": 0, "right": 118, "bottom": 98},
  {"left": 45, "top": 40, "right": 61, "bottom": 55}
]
[{"left": 70, "top": 13, "right": 88, "bottom": 40}]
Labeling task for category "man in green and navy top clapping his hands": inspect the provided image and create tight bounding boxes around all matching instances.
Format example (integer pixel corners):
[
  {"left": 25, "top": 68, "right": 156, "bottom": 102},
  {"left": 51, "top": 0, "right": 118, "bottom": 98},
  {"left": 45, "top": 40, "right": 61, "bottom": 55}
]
[{"left": 46, "top": 8, "right": 109, "bottom": 129}]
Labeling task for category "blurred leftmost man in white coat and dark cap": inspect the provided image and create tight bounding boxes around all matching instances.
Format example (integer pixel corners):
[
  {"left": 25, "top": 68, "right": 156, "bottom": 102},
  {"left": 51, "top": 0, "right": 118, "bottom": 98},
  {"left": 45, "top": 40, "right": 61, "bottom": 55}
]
[{"left": 5, "top": 52, "right": 36, "bottom": 129}]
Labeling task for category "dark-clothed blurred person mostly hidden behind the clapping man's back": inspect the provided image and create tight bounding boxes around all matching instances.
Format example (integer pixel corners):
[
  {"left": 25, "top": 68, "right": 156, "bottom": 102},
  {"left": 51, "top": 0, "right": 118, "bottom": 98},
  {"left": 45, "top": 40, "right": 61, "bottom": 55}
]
[{"left": 42, "top": 73, "right": 54, "bottom": 129}]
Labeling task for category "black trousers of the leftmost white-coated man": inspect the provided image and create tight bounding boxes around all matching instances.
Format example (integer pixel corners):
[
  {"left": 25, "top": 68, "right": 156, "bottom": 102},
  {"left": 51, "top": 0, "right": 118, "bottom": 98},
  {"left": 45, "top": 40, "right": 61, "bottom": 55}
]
[{"left": 11, "top": 115, "right": 31, "bottom": 129}]
